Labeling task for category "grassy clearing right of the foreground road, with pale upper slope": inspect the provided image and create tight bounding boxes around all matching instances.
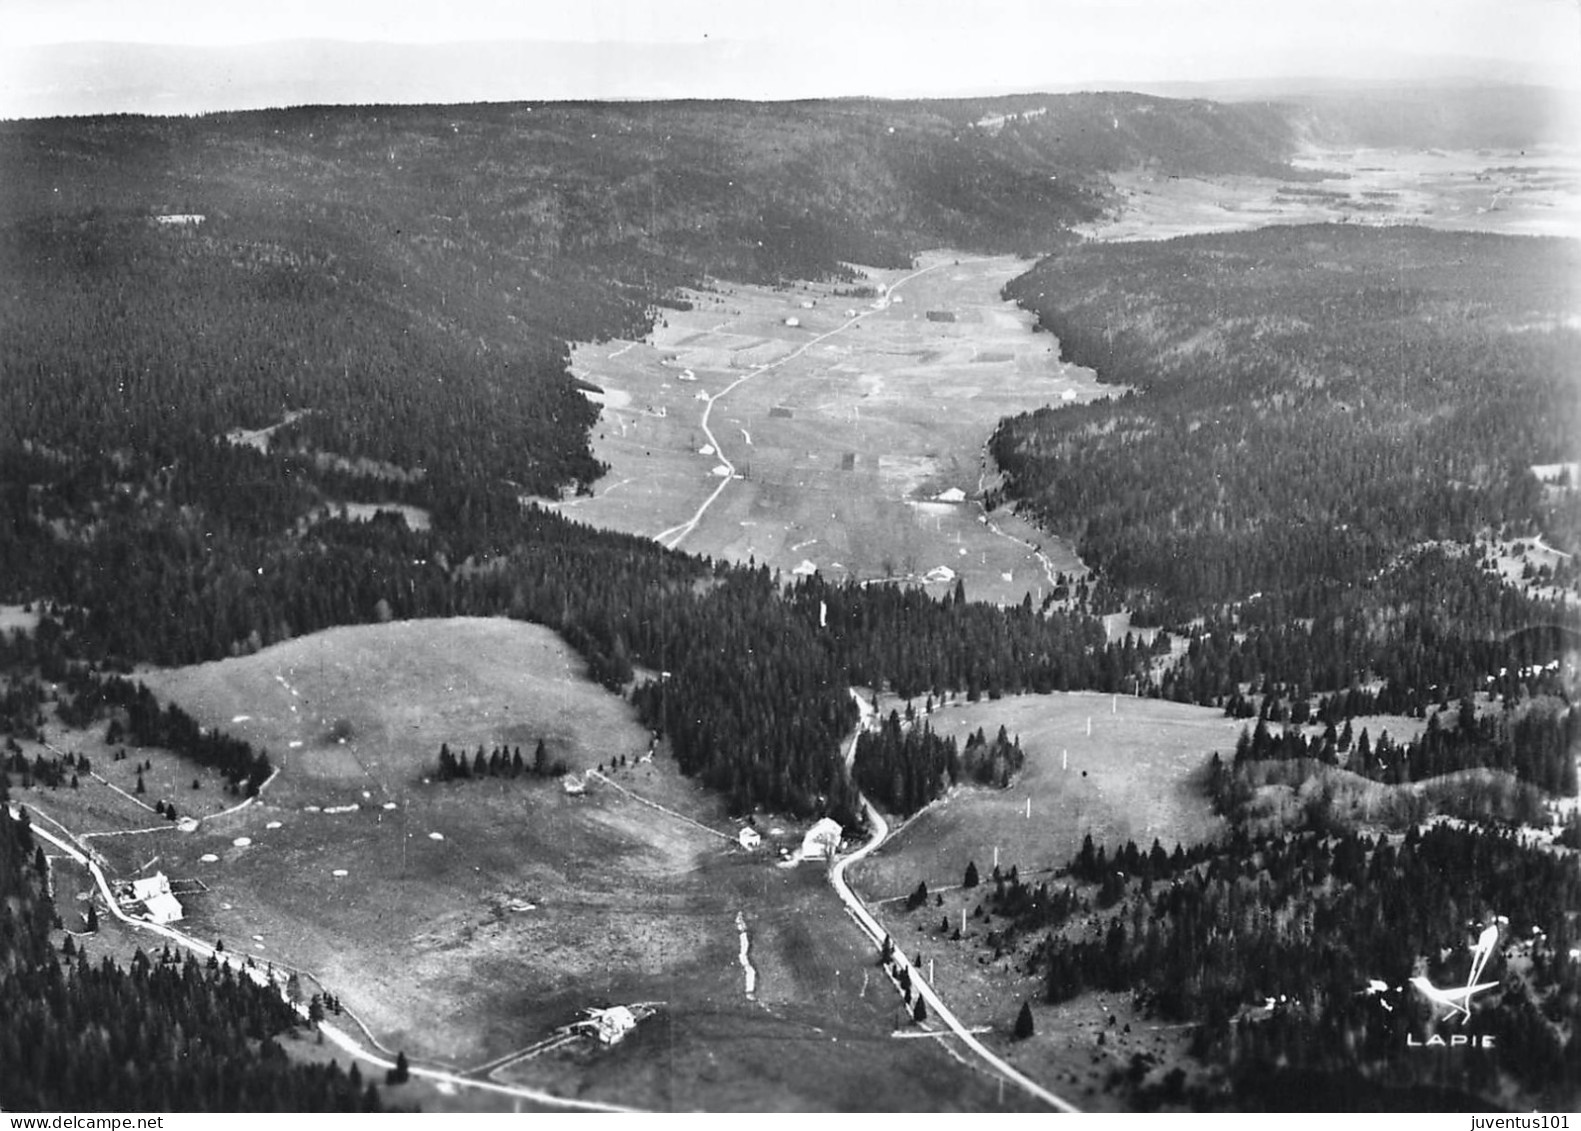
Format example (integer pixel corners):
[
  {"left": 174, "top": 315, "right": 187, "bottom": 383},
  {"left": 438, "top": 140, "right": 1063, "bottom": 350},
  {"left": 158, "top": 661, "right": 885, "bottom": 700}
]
[{"left": 854, "top": 693, "right": 1241, "bottom": 1110}]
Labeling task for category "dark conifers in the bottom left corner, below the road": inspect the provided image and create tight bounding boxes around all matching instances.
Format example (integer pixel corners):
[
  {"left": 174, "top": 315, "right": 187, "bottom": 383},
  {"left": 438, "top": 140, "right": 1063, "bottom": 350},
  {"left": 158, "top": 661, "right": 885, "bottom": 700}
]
[{"left": 0, "top": 800, "right": 392, "bottom": 1112}]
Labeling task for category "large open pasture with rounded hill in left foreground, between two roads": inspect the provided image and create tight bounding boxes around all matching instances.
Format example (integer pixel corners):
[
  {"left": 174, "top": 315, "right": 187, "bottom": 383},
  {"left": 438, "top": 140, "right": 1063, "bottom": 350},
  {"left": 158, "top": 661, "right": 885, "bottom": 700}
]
[{"left": 19, "top": 618, "right": 1017, "bottom": 1110}]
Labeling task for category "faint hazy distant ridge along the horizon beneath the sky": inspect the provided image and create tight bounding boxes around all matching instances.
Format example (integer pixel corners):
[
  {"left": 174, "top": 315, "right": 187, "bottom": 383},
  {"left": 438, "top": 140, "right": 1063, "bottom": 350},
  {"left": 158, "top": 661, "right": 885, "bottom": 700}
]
[{"left": 12, "top": 40, "right": 1581, "bottom": 130}]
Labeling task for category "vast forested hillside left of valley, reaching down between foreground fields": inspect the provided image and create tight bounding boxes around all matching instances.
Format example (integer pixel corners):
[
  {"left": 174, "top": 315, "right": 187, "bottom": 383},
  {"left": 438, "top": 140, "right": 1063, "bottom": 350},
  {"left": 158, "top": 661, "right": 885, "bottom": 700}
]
[{"left": 0, "top": 95, "right": 1309, "bottom": 819}]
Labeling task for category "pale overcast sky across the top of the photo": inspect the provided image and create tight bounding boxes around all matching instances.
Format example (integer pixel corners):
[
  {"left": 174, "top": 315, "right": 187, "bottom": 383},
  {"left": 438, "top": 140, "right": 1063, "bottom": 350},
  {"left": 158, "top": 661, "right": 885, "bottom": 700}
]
[{"left": 0, "top": 0, "right": 1581, "bottom": 115}]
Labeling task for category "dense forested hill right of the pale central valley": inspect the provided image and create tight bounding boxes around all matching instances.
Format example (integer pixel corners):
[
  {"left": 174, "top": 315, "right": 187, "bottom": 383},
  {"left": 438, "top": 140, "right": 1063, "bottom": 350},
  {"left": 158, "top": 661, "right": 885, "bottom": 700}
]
[{"left": 993, "top": 225, "right": 1581, "bottom": 651}]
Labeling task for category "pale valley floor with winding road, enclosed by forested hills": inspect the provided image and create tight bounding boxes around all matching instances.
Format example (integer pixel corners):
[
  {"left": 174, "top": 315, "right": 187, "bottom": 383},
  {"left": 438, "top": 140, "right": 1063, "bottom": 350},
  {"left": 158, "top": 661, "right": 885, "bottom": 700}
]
[{"left": 561, "top": 253, "right": 1113, "bottom": 601}]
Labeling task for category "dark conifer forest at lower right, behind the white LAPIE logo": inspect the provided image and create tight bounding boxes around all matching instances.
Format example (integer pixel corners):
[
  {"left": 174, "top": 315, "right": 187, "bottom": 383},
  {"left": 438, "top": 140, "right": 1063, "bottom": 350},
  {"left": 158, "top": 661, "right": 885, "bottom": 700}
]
[{"left": 982, "top": 826, "right": 1581, "bottom": 1110}]
